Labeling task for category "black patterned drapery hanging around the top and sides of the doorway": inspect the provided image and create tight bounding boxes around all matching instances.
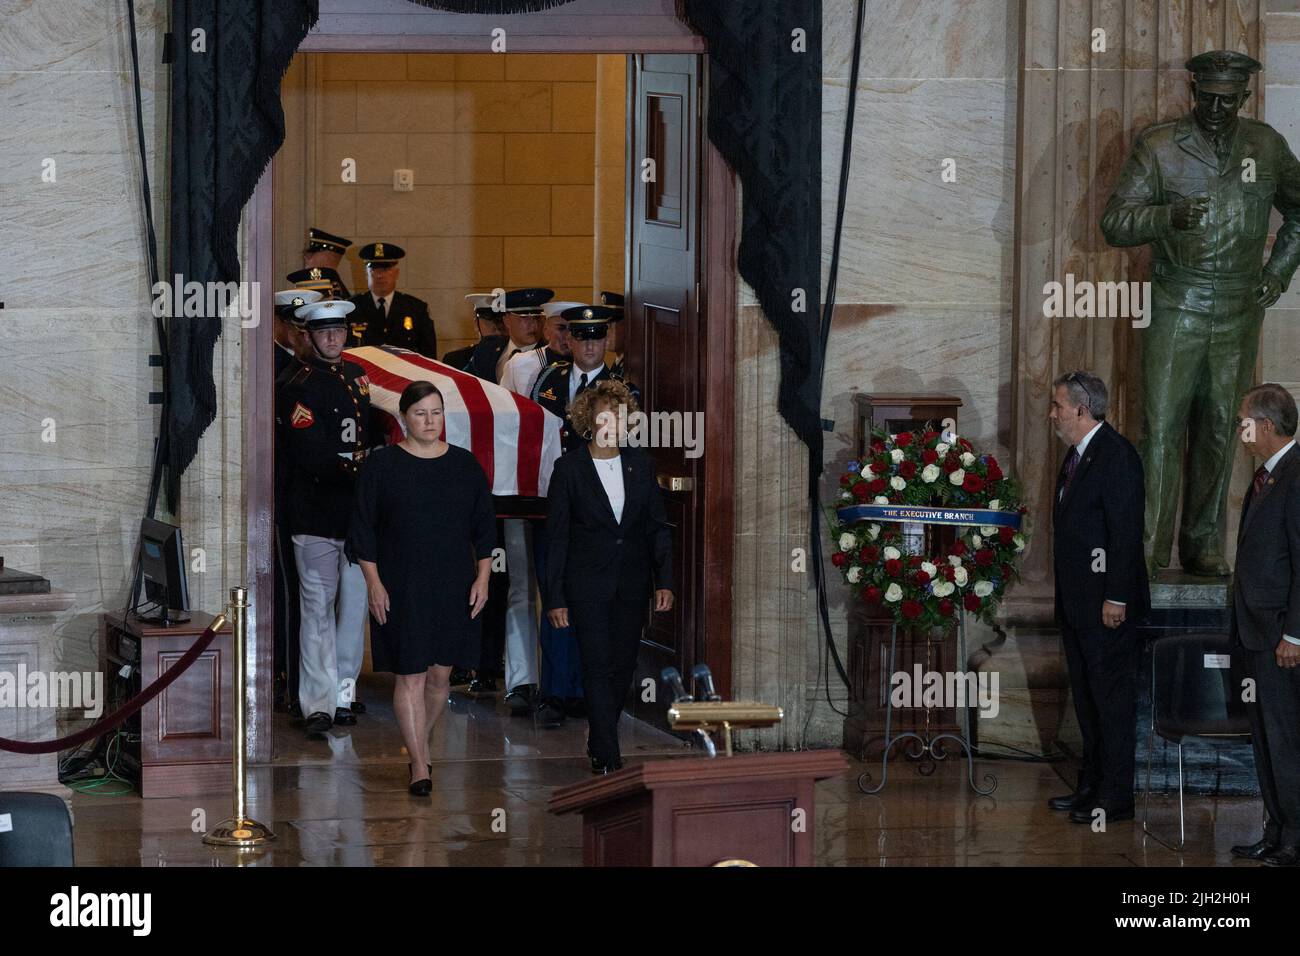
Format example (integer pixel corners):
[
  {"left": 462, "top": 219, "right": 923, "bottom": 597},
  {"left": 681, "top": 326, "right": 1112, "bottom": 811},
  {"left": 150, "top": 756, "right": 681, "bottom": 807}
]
[{"left": 164, "top": 0, "right": 822, "bottom": 512}]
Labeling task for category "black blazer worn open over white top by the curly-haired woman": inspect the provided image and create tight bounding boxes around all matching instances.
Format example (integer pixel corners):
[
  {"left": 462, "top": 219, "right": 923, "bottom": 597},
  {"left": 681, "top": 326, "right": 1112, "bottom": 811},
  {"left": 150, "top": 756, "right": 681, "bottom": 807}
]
[{"left": 543, "top": 445, "right": 672, "bottom": 610}]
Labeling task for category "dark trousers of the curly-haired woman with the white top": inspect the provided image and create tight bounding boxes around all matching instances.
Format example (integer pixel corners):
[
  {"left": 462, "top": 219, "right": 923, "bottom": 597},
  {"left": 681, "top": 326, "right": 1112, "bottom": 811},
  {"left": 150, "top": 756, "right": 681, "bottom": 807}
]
[{"left": 568, "top": 598, "right": 649, "bottom": 763}]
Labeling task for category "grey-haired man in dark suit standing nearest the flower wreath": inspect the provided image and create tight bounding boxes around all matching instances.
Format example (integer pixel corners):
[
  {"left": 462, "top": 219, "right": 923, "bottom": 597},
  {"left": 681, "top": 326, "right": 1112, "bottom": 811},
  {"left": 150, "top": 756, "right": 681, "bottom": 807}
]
[{"left": 1048, "top": 372, "right": 1151, "bottom": 825}]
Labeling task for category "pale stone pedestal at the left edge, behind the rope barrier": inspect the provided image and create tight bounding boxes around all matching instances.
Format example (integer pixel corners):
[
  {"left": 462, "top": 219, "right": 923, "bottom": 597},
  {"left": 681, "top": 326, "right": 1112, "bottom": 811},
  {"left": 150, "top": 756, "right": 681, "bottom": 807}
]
[{"left": 0, "top": 570, "right": 77, "bottom": 800}]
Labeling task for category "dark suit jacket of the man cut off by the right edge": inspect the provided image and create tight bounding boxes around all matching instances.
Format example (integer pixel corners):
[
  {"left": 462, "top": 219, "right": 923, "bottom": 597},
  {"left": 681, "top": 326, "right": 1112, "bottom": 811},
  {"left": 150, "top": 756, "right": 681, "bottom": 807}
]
[{"left": 1229, "top": 446, "right": 1300, "bottom": 650}]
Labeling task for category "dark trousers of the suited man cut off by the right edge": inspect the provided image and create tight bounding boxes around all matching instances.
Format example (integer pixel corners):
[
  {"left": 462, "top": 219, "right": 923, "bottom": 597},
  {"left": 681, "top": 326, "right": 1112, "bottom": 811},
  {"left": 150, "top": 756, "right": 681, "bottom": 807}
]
[{"left": 1238, "top": 646, "right": 1300, "bottom": 847}]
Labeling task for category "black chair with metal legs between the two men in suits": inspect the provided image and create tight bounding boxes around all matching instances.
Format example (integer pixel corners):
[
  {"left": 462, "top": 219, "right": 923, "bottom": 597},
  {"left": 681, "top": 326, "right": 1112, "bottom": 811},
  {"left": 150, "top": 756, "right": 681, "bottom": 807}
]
[{"left": 1141, "top": 633, "right": 1251, "bottom": 853}]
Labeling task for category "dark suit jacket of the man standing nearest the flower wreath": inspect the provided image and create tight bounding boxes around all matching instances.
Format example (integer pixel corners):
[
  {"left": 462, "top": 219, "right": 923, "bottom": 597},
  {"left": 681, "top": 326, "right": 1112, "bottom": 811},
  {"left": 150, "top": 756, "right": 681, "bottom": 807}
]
[{"left": 1052, "top": 421, "right": 1151, "bottom": 630}]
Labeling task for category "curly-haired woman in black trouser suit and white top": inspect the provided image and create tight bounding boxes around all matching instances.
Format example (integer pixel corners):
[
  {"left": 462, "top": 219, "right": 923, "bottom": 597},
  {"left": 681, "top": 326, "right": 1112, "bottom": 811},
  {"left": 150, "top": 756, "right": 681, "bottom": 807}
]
[{"left": 546, "top": 378, "right": 672, "bottom": 774}]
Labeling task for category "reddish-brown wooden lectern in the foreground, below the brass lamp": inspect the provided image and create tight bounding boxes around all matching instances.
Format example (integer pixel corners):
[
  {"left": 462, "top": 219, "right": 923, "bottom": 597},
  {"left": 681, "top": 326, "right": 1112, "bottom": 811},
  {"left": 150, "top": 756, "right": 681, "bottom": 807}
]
[{"left": 550, "top": 750, "right": 848, "bottom": 866}]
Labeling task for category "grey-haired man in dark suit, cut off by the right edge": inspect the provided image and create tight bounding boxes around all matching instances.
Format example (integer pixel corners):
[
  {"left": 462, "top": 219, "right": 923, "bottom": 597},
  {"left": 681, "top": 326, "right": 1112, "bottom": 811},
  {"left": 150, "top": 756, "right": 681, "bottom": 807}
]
[{"left": 1229, "top": 384, "right": 1300, "bottom": 866}]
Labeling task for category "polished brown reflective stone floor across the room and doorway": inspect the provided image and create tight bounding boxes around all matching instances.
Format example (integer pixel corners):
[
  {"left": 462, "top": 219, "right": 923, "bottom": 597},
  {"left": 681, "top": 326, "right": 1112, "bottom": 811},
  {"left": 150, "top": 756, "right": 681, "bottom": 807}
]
[{"left": 63, "top": 675, "right": 1260, "bottom": 866}]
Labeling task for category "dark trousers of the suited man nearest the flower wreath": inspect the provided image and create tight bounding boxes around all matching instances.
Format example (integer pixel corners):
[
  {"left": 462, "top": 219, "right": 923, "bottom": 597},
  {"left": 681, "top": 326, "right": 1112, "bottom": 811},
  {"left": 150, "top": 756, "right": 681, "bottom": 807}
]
[{"left": 1062, "top": 621, "right": 1138, "bottom": 806}]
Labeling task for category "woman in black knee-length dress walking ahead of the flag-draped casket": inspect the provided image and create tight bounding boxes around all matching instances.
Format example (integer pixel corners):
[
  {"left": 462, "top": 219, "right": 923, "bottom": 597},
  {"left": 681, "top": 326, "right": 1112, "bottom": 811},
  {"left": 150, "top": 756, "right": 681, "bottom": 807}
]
[{"left": 350, "top": 381, "right": 497, "bottom": 796}]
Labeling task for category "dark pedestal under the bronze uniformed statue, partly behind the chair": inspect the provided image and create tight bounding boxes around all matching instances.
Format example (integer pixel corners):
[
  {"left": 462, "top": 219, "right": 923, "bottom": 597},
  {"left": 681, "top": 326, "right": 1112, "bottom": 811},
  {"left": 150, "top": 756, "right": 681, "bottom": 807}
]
[{"left": 1138, "top": 571, "right": 1260, "bottom": 796}]
